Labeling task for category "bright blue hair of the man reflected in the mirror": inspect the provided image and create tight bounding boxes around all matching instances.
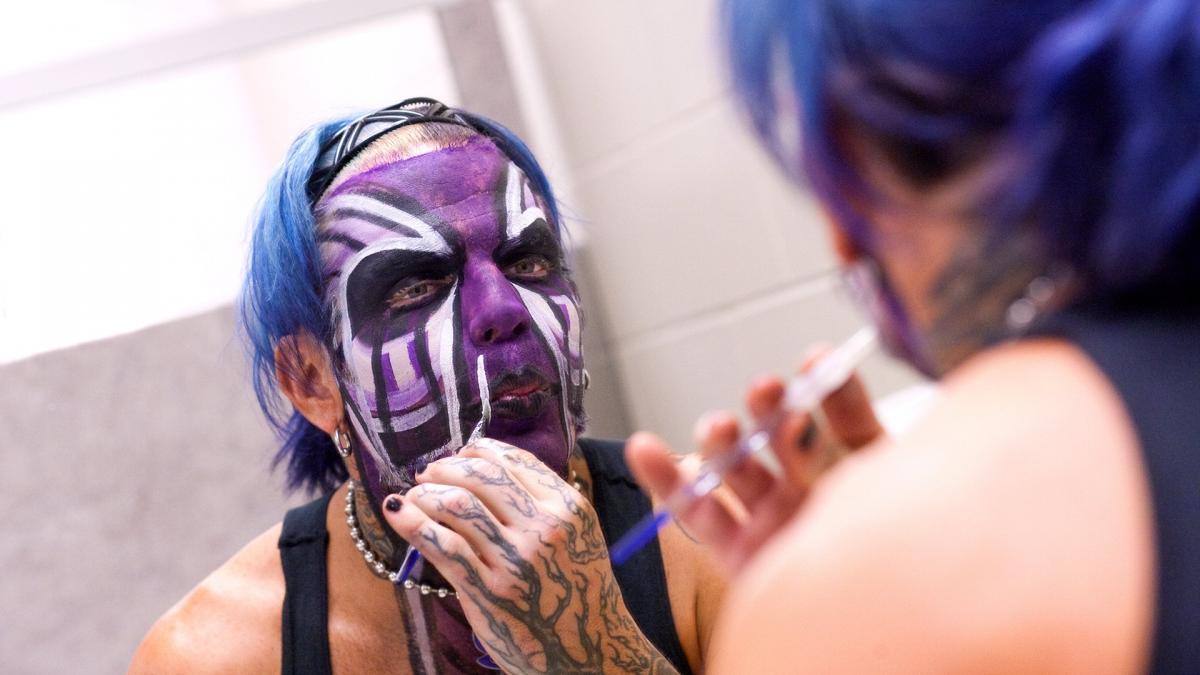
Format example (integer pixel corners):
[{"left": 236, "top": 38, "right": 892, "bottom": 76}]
[{"left": 239, "top": 110, "right": 562, "bottom": 492}]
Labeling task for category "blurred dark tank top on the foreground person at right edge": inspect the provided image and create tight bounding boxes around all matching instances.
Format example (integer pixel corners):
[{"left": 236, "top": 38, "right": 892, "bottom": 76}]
[{"left": 1034, "top": 307, "right": 1200, "bottom": 674}]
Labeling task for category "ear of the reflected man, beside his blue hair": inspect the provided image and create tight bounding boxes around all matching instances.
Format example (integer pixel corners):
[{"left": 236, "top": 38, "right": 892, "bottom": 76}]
[{"left": 275, "top": 333, "right": 343, "bottom": 434}]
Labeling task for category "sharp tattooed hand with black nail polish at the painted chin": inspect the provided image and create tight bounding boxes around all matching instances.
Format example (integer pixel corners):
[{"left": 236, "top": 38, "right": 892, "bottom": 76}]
[{"left": 385, "top": 438, "right": 674, "bottom": 673}]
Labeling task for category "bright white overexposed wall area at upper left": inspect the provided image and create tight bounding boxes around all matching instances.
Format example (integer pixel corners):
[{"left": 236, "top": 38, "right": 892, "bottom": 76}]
[{"left": 0, "top": 0, "right": 457, "bottom": 364}]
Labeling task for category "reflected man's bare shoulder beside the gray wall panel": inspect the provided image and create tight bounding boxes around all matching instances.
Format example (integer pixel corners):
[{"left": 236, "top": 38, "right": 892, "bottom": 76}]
[{"left": 130, "top": 525, "right": 284, "bottom": 674}]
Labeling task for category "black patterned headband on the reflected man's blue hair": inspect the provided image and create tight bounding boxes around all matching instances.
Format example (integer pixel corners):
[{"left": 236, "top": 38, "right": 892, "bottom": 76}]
[{"left": 306, "top": 97, "right": 486, "bottom": 204}]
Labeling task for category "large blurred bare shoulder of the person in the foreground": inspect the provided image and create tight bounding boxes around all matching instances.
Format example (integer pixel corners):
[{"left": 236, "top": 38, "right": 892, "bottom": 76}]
[{"left": 718, "top": 341, "right": 1153, "bottom": 673}]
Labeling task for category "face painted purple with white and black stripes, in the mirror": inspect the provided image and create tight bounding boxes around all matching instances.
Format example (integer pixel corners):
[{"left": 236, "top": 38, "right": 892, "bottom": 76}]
[{"left": 318, "top": 138, "right": 583, "bottom": 500}]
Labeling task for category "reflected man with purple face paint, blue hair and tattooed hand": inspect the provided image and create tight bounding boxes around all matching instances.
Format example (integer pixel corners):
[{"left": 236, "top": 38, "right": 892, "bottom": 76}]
[{"left": 133, "top": 98, "right": 724, "bottom": 673}]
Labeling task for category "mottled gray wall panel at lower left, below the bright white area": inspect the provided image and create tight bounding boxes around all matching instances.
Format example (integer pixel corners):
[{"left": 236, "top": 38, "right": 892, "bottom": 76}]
[{"left": 0, "top": 309, "right": 298, "bottom": 673}]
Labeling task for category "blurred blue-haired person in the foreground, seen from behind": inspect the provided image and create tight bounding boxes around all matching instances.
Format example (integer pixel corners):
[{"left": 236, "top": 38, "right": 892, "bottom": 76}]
[{"left": 626, "top": 0, "right": 1200, "bottom": 674}]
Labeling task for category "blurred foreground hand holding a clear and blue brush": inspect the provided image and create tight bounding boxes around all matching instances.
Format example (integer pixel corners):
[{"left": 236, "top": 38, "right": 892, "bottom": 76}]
[{"left": 625, "top": 348, "right": 883, "bottom": 573}]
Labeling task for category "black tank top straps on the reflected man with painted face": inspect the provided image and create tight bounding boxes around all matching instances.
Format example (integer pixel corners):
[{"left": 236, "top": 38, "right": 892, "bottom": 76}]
[{"left": 280, "top": 438, "right": 691, "bottom": 675}]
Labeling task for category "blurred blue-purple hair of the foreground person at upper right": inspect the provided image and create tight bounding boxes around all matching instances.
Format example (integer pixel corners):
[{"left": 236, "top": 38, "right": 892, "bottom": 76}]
[{"left": 721, "top": 0, "right": 1200, "bottom": 301}]
